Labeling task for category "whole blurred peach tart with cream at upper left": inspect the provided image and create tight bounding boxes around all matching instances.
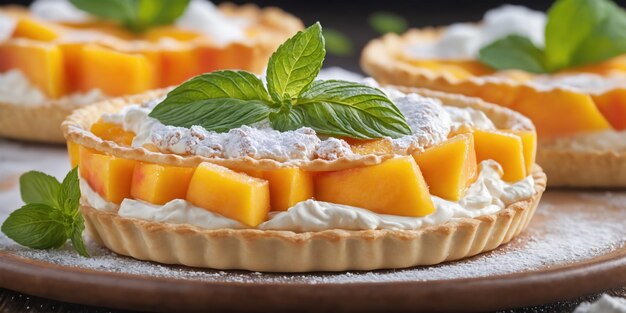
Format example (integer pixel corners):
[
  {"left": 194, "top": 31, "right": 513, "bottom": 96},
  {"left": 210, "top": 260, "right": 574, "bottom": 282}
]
[{"left": 0, "top": 0, "right": 302, "bottom": 143}]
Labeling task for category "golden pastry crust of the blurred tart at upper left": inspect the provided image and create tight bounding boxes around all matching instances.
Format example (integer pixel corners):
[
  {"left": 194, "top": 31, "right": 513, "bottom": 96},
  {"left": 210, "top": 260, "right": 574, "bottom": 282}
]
[{"left": 0, "top": 3, "right": 303, "bottom": 143}]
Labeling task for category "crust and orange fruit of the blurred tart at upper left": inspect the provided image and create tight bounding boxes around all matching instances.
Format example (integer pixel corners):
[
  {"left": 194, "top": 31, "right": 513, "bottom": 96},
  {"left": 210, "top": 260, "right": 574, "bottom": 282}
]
[{"left": 0, "top": 4, "right": 303, "bottom": 143}]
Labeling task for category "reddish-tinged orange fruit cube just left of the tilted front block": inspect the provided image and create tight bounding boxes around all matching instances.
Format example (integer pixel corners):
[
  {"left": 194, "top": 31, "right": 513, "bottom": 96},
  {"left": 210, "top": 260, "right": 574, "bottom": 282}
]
[{"left": 130, "top": 162, "right": 194, "bottom": 204}]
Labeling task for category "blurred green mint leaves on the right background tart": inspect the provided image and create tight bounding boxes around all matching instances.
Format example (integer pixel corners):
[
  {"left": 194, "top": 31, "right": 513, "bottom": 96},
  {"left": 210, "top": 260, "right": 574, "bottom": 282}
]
[{"left": 478, "top": 0, "right": 626, "bottom": 73}]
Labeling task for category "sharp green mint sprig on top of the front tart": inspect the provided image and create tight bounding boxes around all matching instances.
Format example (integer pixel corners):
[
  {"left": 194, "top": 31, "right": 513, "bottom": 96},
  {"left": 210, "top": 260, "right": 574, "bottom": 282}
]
[{"left": 150, "top": 23, "right": 411, "bottom": 139}]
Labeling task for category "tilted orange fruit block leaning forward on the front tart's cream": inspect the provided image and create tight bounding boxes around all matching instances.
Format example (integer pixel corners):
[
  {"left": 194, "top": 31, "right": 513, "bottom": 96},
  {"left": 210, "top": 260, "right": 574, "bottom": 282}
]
[{"left": 187, "top": 162, "right": 270, "bottom": 227}]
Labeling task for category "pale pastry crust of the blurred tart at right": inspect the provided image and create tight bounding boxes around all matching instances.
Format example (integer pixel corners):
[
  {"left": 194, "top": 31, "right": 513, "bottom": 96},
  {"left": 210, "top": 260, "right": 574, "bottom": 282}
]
[{"left": 361, "top": 28, "right": 626, "bottom": 188}]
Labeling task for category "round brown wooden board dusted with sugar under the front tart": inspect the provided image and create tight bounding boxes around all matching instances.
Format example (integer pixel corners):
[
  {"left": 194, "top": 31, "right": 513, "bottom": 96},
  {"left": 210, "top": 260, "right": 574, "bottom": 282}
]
[{"left": 0, "top": 191, "right": 626, "bottom": 312}]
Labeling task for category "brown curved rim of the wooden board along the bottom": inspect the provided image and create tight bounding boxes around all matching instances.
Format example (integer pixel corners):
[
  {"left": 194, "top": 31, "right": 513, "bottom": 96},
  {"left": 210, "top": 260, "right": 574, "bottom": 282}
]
[{"left": 0, "top": 247, "right": 626, "bottom": 312}]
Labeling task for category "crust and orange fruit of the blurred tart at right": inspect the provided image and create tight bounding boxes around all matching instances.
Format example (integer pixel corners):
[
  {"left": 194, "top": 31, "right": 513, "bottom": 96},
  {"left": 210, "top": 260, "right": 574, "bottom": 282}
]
[{"left": 361, "top": 28, "right": 626, "bottom": 187}]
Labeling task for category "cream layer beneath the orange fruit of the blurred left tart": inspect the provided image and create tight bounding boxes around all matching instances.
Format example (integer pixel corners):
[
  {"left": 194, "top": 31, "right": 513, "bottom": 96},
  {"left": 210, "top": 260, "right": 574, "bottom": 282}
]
[{"left": 0, "top": 69, "right": 106, "bottom": 107}]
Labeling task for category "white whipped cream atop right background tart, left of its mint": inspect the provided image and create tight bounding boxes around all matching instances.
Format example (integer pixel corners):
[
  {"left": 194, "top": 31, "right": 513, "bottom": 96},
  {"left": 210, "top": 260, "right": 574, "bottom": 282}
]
[{"left": 407, "top": 5, "right": 547, "bottom": 59}]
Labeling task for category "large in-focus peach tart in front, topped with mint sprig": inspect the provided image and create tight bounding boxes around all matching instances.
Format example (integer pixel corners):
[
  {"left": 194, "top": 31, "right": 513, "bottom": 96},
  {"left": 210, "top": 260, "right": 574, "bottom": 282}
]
[{"left": 63, "top": 24, "right": 546, "bottom": 272}]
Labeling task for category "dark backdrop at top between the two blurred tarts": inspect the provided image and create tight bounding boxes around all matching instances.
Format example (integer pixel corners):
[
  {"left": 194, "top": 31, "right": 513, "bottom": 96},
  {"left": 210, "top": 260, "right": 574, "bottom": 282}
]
[{"left": 7, "top": 0, "right": 626, "bottom": 71}]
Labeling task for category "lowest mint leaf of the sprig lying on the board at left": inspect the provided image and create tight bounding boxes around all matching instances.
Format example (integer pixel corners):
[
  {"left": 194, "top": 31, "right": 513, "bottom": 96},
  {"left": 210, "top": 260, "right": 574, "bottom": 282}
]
[{"left": 1, "top": 203, "right": 67, "bottom": 249}]
